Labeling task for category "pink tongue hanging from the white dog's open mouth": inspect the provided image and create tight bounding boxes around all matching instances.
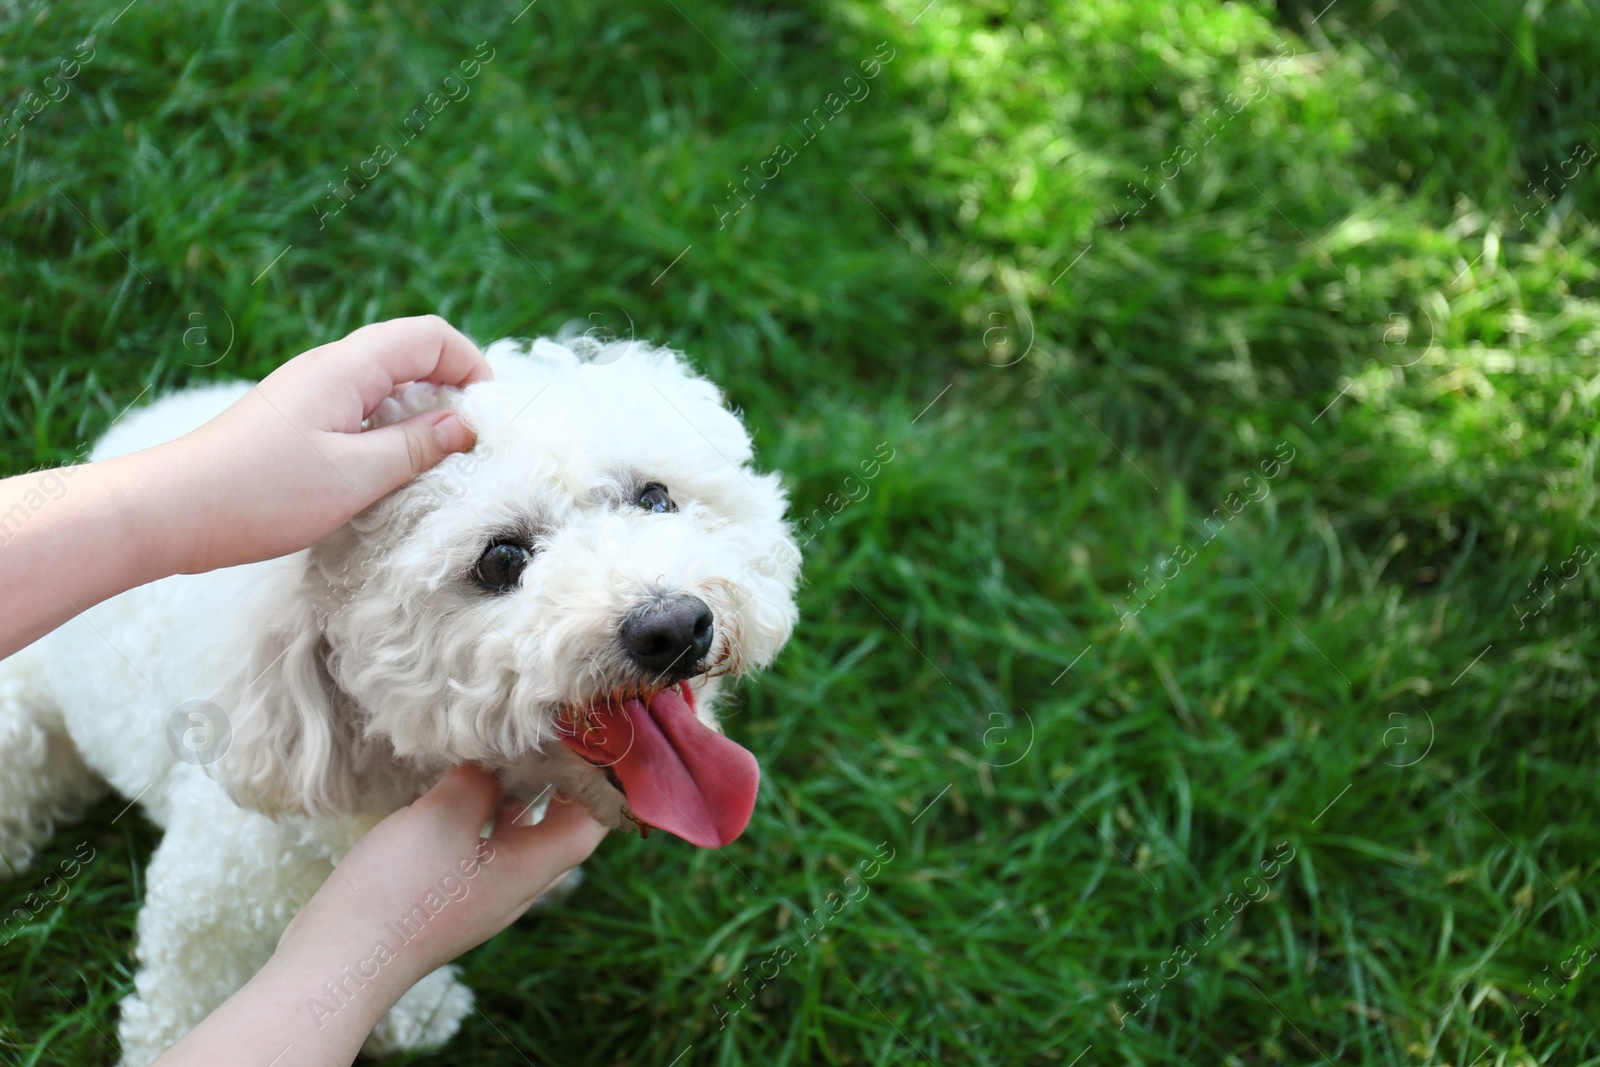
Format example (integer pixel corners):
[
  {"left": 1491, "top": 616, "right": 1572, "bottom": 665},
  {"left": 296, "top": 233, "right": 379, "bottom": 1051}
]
[{"left": 562, "top": 689, "right": 762, "bottom": 848}]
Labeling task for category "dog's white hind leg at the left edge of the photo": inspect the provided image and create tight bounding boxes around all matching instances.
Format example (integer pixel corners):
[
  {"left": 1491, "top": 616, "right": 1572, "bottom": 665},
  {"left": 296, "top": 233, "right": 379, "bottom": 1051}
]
[{"left": 0, "top": 651, "right": 106, "bottom": 878}]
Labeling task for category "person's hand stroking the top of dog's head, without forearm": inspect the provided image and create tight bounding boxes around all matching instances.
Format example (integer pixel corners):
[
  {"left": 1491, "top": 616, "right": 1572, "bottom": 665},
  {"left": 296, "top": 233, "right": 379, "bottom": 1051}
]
[{"left": 144, "top": 315, "right": 493, "bottom": 573}]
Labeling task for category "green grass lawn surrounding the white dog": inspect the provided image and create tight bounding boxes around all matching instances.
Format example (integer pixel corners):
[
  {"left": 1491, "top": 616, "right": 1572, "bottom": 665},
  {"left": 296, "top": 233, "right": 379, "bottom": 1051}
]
[{"left": 0, "top": 0, "right": 1600, "bottom": 1065}]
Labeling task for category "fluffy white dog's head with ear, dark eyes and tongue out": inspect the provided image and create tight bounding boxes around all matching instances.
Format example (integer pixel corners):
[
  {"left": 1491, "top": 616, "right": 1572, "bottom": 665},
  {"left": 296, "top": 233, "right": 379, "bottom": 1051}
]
[{"left": 218, "top": 338, "right": 798, "bottom": 846}]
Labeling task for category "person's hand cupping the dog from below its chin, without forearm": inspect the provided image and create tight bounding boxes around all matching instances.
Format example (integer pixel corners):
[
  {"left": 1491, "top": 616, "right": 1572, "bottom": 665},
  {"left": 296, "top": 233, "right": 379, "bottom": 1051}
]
[{"left": 277, "top": 766, "right": 606, "bottom": 997}]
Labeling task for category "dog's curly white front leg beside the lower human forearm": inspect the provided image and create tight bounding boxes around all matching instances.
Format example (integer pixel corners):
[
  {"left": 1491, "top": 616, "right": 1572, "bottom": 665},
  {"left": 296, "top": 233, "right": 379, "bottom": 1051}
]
[{"left": 118, "top": 777, "right": 333, "bottom": 1067}]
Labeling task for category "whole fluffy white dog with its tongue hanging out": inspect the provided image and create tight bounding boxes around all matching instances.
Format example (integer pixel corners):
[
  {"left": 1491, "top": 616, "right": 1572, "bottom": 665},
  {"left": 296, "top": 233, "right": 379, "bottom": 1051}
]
[{"left": 0, "top": 338, "right": 798, "bottom": 1065}]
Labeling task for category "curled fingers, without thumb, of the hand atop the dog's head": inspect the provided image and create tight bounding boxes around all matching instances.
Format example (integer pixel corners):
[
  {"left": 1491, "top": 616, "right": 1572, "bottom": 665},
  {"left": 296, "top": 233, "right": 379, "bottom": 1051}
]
[{"left": 328, "top": 315, "right": 494, "bottom": 414}]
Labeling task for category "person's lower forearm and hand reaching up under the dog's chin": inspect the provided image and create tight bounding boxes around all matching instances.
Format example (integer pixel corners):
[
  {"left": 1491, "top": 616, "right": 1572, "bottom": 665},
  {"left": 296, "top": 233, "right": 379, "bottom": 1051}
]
[{"left": 157, "top": 766, "right": 606, "bottom": 1067}]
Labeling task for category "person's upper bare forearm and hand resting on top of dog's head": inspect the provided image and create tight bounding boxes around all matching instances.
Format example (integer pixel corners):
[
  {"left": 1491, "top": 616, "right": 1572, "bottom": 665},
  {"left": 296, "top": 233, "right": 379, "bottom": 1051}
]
[{"left": 0, "top": 315, "right": 490, "bottom": 657}]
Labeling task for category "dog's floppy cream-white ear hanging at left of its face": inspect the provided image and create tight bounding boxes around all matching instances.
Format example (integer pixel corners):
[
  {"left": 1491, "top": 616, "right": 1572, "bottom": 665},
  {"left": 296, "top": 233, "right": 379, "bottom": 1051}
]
[{"left": 211, "top": 545, "right": 360, "bottom": 816}]
